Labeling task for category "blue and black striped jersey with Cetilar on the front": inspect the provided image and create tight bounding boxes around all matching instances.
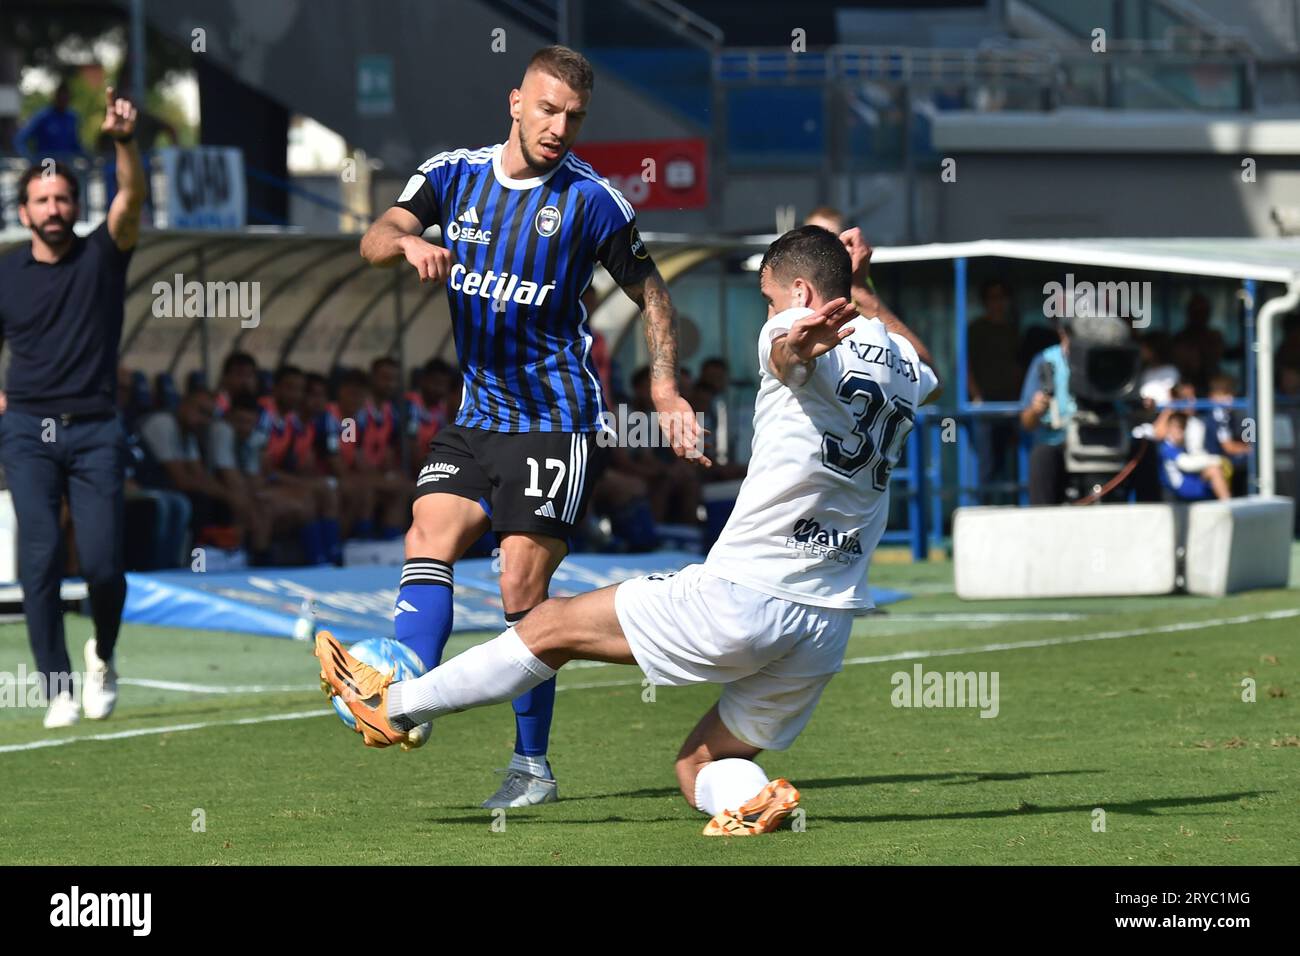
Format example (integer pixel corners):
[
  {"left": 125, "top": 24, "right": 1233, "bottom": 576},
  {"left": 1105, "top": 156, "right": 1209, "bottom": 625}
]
[{"left": 395, "top": 144, "right": 654, "bottom": 432}]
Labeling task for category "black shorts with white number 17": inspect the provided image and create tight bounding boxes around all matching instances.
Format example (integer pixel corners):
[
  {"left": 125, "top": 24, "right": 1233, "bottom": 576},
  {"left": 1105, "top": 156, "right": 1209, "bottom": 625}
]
[{"left": 415, "top": 425, "right": 599, "bottom": 540}]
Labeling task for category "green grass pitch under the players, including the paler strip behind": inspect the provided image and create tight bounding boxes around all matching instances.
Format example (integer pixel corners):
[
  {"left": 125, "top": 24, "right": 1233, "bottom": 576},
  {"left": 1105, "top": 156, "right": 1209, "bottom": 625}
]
[{"left": 0, "top": 554, "right": 1300, "bottom": 865}]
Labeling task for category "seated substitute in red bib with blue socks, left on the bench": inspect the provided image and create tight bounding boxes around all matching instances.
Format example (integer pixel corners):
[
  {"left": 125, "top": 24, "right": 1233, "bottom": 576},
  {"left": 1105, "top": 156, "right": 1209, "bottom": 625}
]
[{"left": 259, "top": 365, "right": 343, "bottom": 564}]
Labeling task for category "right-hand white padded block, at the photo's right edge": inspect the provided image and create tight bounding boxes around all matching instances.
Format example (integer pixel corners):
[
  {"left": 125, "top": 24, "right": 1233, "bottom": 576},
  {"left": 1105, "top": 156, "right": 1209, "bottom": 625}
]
[{"left": 1184, "top": 497, "right": 1295, "bottom": 597}]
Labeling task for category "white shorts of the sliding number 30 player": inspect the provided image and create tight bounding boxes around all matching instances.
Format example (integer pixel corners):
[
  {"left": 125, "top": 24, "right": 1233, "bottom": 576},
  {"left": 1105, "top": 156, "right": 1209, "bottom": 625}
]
[{"left": 614, "top": 564, "right": 853, "bottom": 750}]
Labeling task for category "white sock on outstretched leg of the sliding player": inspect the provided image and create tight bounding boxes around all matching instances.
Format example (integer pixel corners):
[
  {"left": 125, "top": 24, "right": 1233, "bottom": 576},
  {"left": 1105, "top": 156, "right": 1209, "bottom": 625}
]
[{"left": 387, "top": 627, "right": 555, "bottom": 724}]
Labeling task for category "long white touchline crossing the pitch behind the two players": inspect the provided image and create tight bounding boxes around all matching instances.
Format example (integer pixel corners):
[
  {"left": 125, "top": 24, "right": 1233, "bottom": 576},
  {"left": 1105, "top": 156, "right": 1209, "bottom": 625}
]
[{"left": 0, "top": 607, "right": 1300, "bottom": 753}]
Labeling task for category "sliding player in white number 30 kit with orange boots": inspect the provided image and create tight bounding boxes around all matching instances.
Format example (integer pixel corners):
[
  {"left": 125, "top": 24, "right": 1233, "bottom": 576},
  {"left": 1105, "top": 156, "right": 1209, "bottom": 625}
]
[{"left": 316, "top": 226, "right": 939, "bottom": 835}]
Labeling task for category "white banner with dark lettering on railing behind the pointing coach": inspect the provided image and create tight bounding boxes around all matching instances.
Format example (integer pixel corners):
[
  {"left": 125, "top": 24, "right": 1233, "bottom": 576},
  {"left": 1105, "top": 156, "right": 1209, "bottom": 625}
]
[{"left": 159, "top": 146, "right": 246, "bottom": 229}]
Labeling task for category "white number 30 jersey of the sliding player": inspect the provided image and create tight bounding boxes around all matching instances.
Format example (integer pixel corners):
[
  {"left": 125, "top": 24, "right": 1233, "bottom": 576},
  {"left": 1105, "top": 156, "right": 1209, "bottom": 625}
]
[{"left": 705, "top": 308, "right": 939, "bottom": 607}]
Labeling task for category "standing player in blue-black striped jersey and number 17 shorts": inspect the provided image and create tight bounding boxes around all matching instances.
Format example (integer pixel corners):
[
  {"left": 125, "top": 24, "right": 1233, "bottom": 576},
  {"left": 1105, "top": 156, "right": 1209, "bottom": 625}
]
[{"left": 361, "top": 47, "right": 709, "bottom": 808}]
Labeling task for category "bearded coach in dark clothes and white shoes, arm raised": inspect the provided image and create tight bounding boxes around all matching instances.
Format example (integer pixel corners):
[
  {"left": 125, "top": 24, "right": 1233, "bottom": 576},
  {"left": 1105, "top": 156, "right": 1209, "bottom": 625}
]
[{"left": 0, "top": 87, "right": 144, "bottom": 727}]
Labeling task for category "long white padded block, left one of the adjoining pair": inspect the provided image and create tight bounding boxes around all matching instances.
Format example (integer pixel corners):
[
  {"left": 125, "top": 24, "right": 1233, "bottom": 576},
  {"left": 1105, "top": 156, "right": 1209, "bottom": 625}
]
[{"left": 953, "top": 505, "right": 1177, "bottom": 598}]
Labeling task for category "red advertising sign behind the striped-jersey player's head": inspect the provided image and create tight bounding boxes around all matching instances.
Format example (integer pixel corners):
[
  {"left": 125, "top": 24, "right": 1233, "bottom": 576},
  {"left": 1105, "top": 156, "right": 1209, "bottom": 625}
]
[{"left": 573, "top": 139, "right": 709, "bottom": 209}]
